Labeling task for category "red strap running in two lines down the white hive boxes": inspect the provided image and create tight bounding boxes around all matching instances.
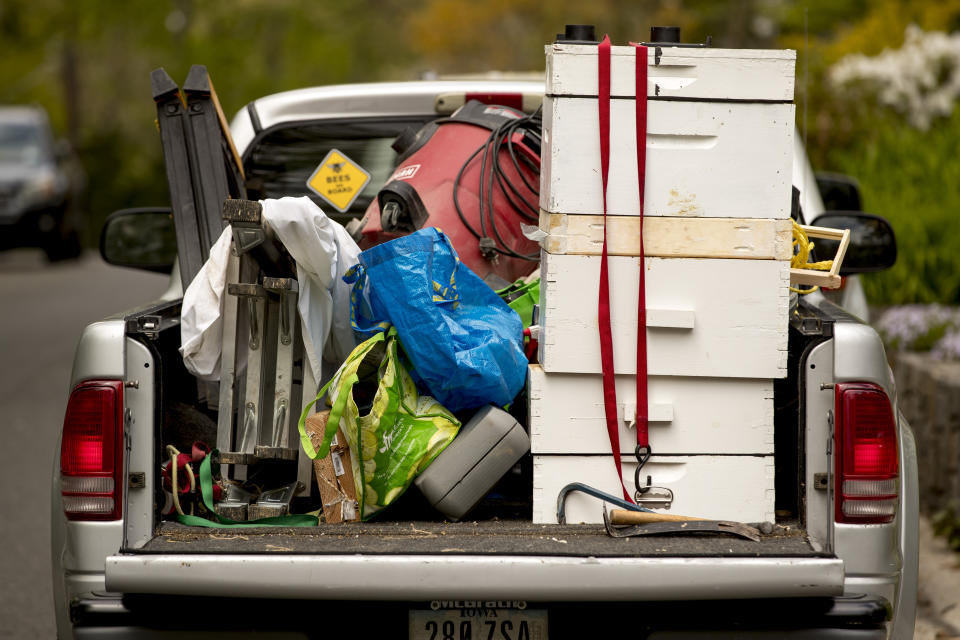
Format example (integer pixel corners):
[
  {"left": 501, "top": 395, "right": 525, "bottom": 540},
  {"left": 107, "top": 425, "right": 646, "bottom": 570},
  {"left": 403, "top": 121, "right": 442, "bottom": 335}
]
[{"left": 597, "top": 36, "right": 650, "bottom": 502}]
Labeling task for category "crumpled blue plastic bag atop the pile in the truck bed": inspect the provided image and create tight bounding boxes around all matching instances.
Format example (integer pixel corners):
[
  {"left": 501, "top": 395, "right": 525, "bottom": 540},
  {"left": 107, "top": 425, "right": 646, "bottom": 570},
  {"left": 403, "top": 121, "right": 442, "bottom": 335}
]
[{"left": 343, "top": 227, "right": 527, "bottom": 411}]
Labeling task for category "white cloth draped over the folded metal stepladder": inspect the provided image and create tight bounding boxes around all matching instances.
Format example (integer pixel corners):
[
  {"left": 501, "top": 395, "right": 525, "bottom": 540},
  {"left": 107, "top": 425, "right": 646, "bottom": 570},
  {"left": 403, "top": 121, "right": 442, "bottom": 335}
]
[{"left": 180, "top": 197, "right": 360, "bottom": 380}]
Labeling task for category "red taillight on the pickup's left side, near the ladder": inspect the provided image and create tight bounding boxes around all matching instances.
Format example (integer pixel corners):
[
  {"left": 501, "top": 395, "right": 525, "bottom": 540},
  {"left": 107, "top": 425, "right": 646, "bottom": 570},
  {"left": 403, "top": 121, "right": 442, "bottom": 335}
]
[{"left": 60, "top": 380, "right": 123, "bottom": 520}]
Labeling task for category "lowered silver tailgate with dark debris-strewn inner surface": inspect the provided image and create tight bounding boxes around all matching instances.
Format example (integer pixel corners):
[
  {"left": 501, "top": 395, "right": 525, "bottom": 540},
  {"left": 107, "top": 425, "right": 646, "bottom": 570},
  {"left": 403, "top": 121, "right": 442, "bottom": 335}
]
[{"left": 106, "top": 520, "right": 844, "bottom": 602}]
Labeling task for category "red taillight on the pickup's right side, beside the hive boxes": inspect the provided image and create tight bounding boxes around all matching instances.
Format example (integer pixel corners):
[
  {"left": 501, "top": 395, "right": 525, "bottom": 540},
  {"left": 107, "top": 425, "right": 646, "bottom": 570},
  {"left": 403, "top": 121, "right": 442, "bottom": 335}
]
[{"left": 835, "top": 382, "right": 899, "bottom": 524}]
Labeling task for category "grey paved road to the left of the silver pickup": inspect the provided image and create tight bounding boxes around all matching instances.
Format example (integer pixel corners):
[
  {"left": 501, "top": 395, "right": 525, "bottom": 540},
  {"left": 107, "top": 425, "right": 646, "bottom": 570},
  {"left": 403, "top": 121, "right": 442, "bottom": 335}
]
[{"left": 0, "top": 250, "right": 166, "bottom": 638}]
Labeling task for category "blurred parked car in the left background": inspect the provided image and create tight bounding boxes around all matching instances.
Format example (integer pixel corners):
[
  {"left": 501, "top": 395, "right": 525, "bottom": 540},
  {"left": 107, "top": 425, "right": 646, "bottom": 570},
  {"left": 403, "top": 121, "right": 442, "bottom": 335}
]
[{"left": 0, "top": 107, "right": 83, "bottom": 260}]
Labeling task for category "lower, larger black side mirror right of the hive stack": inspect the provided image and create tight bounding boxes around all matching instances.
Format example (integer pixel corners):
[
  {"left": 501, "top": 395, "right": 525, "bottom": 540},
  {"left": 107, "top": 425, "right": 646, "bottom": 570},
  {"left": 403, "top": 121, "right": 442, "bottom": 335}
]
[{"left": 812, "top": 211, "right": 897, "bottom": 276}]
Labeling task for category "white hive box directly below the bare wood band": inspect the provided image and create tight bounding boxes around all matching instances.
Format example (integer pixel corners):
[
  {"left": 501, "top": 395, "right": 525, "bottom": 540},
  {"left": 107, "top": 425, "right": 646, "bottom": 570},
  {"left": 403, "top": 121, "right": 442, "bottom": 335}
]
[{"left": 540, "top": 253, "right": 790, "bottom": 378}]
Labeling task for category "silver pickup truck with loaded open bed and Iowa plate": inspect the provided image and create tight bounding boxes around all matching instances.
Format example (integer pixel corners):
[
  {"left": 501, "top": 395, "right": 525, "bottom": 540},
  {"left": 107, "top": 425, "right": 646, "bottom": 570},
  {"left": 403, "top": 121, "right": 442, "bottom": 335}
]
[{"left": 51, "top": 80, "right": 918, "bottom": 640}]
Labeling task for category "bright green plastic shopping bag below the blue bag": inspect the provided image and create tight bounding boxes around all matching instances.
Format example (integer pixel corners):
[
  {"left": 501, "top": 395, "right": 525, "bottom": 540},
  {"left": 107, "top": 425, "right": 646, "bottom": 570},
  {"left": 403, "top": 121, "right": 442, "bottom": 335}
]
[{"left": 300, "top": 327, "right": 460, "bottom": 520}]
